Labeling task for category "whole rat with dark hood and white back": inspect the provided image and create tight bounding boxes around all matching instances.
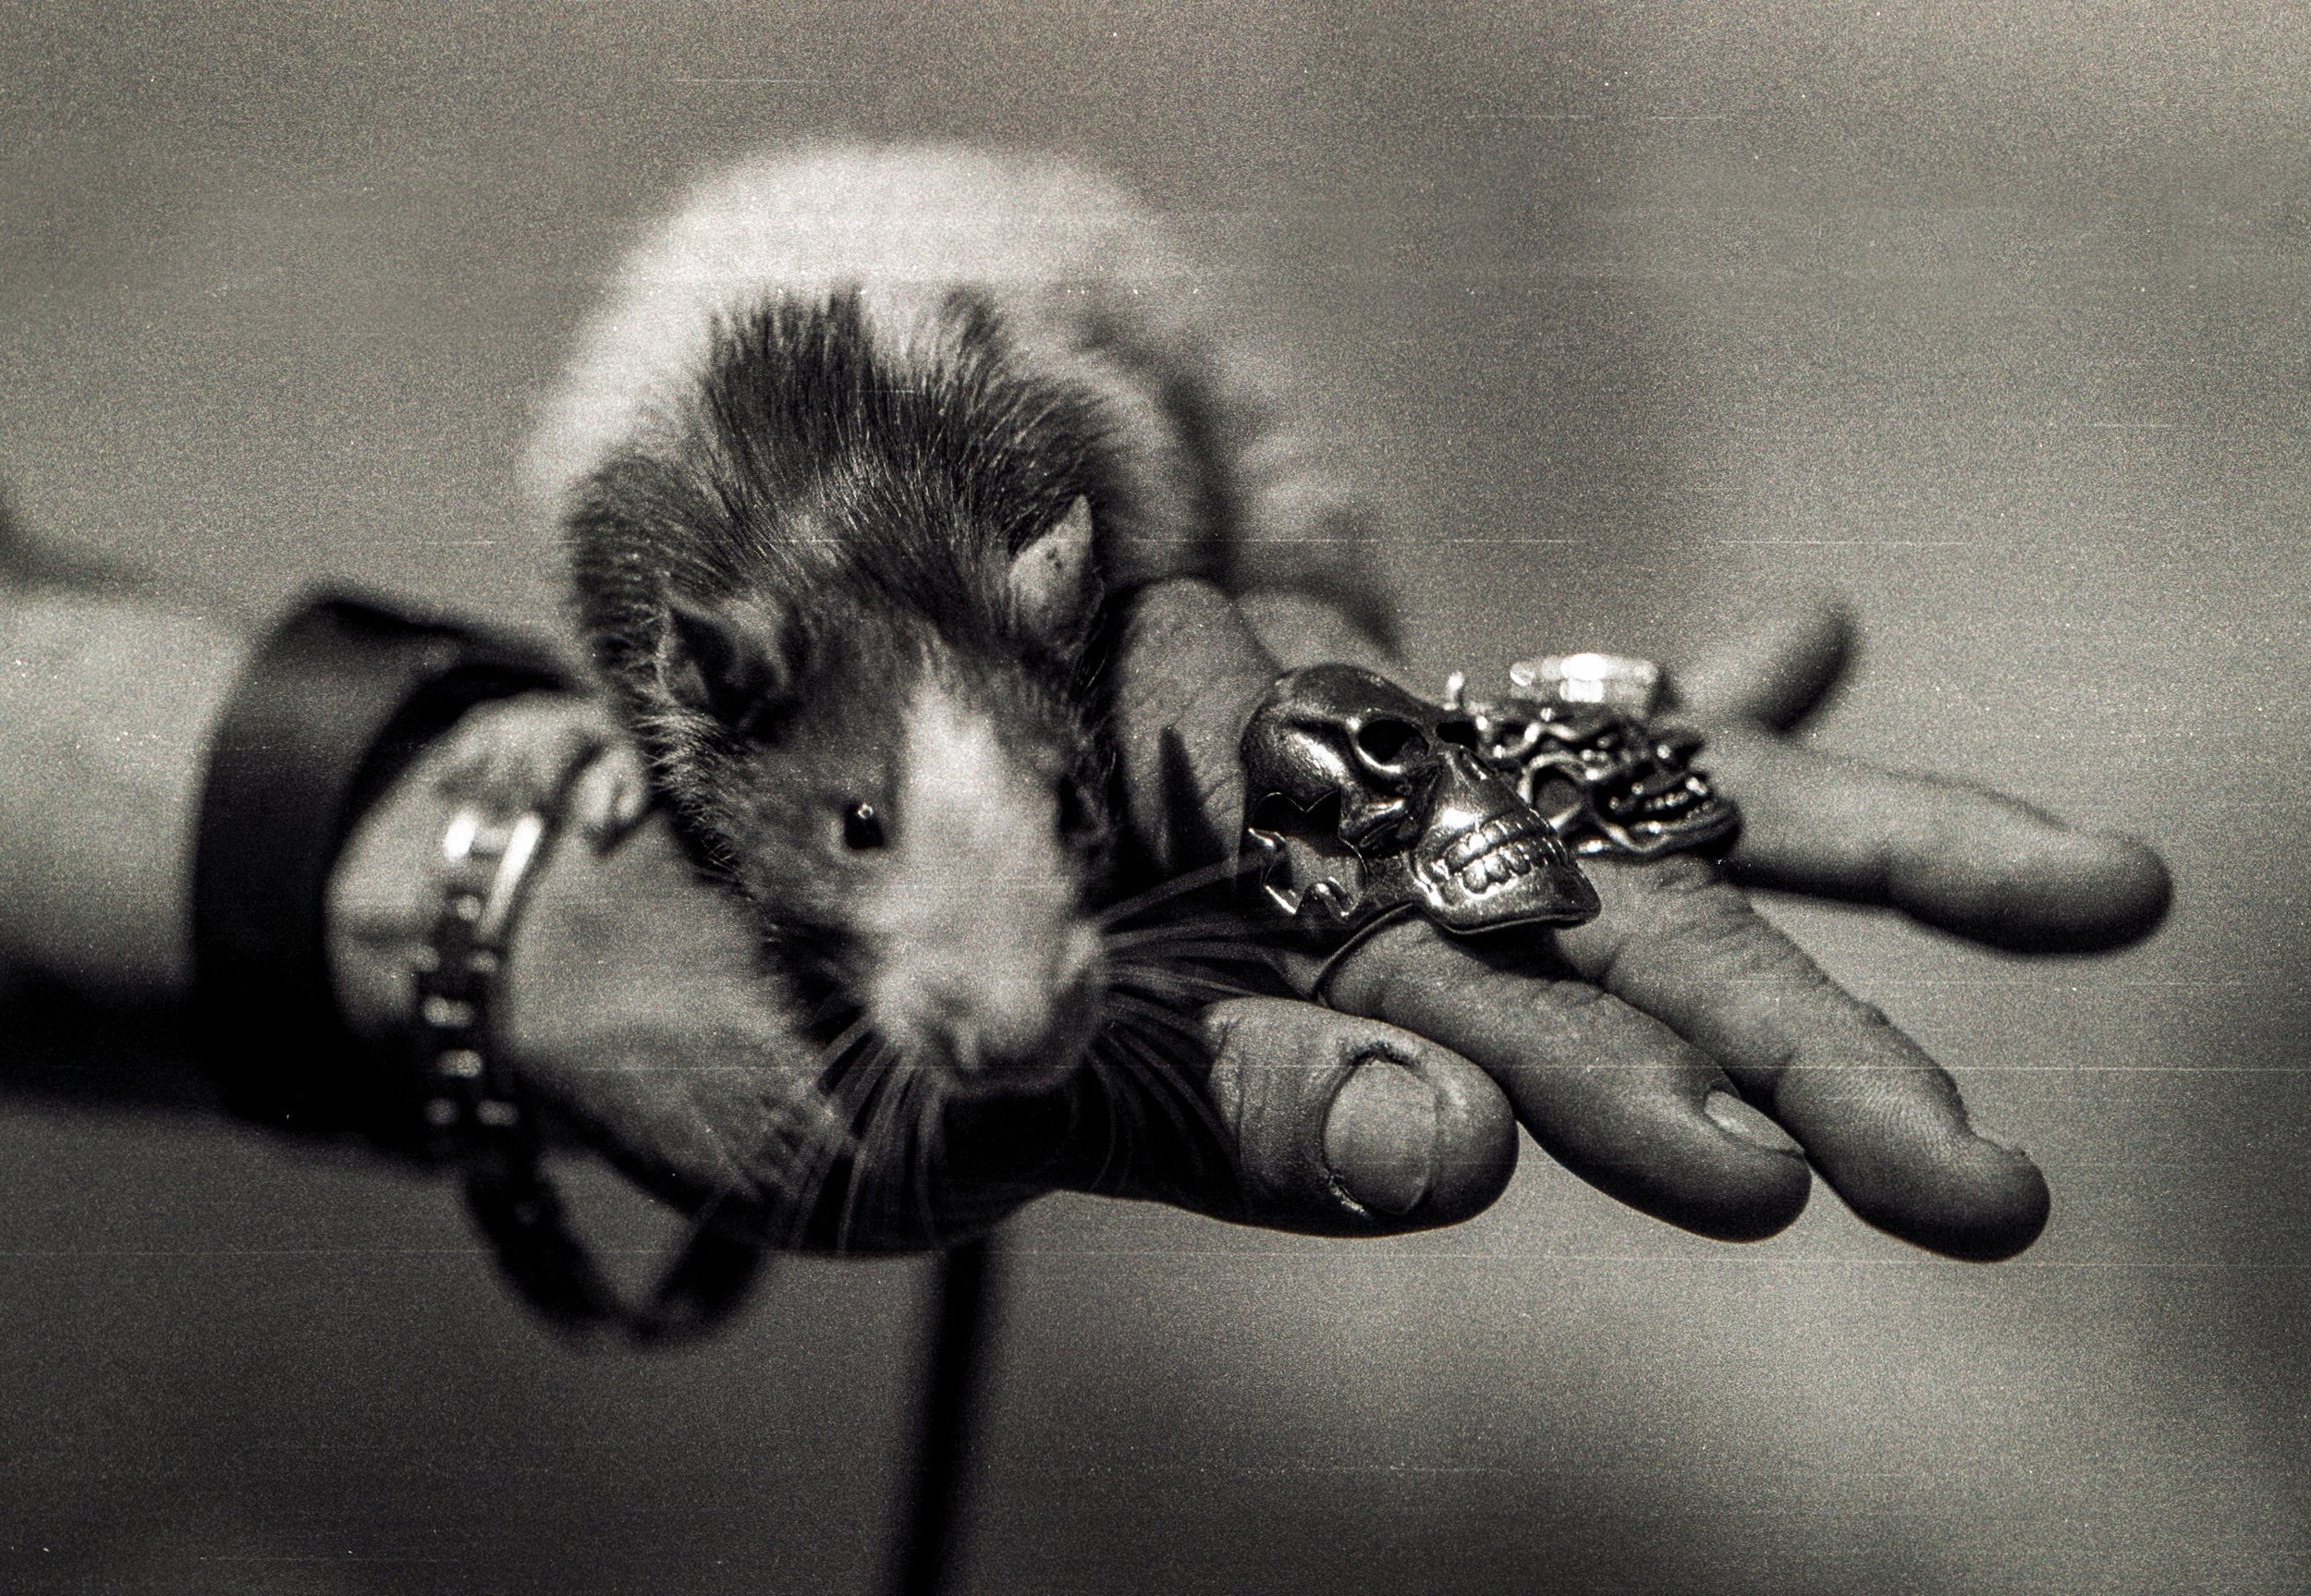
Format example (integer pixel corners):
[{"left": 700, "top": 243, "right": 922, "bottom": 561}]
[{"left": 534, "top": 148, "right": 1352, "bottom": 1099}]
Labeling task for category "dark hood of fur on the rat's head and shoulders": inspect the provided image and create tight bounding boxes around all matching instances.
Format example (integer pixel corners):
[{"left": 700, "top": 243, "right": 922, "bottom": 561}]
[{"left": 569, "top": 293, "right": 1114, "bottom": 1011}]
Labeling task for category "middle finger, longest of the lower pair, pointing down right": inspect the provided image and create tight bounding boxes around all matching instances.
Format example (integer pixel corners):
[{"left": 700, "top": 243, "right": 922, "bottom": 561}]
[{"left": 1558, "top": 855, "right": 2048, "bottom": 1259}]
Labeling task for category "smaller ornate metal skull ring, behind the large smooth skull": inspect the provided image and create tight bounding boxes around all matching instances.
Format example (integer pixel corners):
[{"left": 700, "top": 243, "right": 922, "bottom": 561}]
[{"left": 1445, "top": 653, "right": 1741, "bottom": 859}]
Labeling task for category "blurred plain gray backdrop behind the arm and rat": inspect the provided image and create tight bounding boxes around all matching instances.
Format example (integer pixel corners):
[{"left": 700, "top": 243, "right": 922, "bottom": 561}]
[{"left": 0, "top": 0, "right": 2311, "bottom": 1596}]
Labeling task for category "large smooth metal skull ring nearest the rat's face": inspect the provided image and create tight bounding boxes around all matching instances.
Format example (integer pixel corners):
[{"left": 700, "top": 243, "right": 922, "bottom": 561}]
[{"left": 1243, "top": 665, "right": 1597, "bottom": 943}]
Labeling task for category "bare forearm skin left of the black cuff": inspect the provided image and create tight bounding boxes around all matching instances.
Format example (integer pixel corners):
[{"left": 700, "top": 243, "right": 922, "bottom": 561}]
[{"left": 0, "top": 589, "right": 250, "bottom": 1003}]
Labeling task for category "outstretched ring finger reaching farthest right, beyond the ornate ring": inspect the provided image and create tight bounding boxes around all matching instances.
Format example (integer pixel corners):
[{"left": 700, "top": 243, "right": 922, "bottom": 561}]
[{"left": 1701, "top": 732, "right": 2172, "bottom": 952}]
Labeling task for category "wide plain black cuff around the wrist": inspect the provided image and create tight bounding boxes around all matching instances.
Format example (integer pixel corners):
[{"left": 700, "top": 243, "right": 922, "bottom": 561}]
[{"left": 192, "top": 596, "right": 569, "bottom": 1155}]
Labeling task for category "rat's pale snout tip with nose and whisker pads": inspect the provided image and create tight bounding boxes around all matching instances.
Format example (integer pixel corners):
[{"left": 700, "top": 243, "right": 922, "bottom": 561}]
[{"left": 874, "top": 921, "right": 1105, "bottom": 1090}]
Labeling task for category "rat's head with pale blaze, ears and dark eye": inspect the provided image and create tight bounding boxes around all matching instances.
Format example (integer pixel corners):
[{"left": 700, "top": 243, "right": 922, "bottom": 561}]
[{"left": 661, "top": 501, "right": 1109, "bottom": 1090}]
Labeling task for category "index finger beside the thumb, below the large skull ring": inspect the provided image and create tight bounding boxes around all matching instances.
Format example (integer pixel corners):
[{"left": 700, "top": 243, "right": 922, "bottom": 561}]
[{"left": 1327, "top": 921, "right": 1812, "bottom": 1240}]
